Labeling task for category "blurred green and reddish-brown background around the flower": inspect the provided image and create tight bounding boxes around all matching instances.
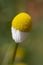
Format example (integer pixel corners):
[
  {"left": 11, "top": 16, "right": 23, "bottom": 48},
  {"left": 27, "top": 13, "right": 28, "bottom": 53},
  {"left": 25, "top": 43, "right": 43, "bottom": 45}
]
[{"left": 0, "top": 0, "right": 43, "bottom": 65}]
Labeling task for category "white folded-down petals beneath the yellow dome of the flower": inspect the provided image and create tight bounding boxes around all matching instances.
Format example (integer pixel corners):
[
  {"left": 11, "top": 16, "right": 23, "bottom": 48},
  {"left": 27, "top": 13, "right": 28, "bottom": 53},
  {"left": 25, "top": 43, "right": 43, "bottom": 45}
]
[{"left": 11, "top": 27, "right": 29, "bottom": 43}]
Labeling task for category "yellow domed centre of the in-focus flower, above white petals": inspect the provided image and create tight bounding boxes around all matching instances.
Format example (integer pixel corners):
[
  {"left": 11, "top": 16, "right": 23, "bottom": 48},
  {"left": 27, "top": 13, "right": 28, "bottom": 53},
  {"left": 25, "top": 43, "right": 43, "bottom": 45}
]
[{"left": 12, "top": 12, "right": 32, "bottom": 32}]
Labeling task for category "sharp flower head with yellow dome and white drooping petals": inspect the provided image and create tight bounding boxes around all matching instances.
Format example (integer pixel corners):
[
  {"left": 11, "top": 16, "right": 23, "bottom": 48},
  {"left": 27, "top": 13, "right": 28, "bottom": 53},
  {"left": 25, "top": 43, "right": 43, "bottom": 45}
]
[{"left": 11, "top": 12, "right": 32, "bottom": 43}]
